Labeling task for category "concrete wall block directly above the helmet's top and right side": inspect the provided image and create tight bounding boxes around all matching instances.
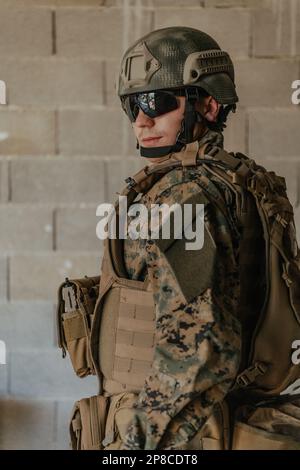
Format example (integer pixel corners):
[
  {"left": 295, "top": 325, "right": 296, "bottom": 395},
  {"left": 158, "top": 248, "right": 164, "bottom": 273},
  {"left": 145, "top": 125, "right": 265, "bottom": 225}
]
[{"left": 155, "top": 8, "right": 250, "bottom": 60}]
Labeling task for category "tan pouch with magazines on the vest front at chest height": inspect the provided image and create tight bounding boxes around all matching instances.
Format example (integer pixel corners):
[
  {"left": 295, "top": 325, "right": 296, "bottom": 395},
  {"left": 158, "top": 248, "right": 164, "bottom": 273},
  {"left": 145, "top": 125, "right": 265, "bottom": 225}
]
[{"left": 57, "top": 276, "right": 100, "bottom": 377}]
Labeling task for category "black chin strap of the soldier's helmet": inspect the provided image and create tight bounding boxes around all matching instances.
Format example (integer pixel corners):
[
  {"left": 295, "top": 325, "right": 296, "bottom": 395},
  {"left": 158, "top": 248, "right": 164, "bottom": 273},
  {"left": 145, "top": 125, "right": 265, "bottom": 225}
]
[{"left": 137, "top": 98, "right": 204, "bottom": 158}]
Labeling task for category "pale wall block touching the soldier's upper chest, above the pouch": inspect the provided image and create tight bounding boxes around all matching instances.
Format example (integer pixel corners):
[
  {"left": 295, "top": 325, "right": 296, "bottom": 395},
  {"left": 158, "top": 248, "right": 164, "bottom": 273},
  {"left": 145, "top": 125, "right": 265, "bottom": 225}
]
[{"left": 56, "top": 207, "right": 102, "bottom": 252}]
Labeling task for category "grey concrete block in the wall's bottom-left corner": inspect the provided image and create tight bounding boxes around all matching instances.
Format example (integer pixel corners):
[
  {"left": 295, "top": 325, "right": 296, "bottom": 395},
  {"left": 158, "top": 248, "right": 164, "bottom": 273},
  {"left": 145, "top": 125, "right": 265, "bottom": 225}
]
[{"left": 0, "top": 399, "right": 55, "bottom": 450}]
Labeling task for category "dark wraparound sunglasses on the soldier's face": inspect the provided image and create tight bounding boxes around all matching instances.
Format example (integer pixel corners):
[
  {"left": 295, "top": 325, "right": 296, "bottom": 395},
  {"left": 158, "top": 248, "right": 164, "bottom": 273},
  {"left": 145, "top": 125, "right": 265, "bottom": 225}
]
[{"left": 121, "top": 90, "right": 185, "bottom": 122}]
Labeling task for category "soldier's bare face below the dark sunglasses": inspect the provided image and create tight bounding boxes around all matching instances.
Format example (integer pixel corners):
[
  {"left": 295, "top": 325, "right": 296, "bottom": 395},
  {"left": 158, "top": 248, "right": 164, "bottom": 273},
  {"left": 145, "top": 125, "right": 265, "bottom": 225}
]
[{"left": 132, "top": 96, "right": 186, "bottom": 151}]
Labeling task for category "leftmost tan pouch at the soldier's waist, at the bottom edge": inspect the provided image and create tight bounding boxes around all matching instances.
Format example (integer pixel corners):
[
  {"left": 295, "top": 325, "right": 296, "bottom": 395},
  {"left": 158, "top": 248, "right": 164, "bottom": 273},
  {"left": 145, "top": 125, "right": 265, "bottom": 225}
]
[{"left": 70, "top": 395, "right": 109, "bottom": 450}]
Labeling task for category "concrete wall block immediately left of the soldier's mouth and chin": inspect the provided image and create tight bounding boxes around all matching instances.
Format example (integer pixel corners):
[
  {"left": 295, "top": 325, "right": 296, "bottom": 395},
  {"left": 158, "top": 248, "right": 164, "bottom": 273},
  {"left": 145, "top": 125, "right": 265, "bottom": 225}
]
[{"left": 59, "top": 109, "right": 123, "bottom": 155}]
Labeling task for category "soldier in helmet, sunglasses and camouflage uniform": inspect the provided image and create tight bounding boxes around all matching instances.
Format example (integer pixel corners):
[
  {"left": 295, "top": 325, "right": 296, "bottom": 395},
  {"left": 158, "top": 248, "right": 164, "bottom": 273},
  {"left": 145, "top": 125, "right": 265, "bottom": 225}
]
[{"left": 62, "top": 27, "right": 300, "bottom": 450}]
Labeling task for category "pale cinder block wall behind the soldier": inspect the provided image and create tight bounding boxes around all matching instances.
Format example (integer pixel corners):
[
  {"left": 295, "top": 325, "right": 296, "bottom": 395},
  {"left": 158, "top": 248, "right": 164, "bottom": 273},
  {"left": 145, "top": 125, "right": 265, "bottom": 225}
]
[{"left": 0, "top": 0, "right": 300, "bottom": 449}]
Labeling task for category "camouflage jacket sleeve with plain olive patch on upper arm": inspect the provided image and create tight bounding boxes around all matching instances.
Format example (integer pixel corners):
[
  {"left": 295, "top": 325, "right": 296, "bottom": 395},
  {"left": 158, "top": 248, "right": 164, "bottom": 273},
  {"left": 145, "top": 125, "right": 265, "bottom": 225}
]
[{"left": 122, "top": 183, "right": 241, "bottom": 450}]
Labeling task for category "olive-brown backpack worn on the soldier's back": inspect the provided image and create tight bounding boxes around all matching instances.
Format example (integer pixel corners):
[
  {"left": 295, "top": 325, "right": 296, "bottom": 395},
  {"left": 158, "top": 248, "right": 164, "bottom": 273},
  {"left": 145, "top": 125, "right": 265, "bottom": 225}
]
[{"left": 195, "top": 149, "right": 300, "bottom": 398}]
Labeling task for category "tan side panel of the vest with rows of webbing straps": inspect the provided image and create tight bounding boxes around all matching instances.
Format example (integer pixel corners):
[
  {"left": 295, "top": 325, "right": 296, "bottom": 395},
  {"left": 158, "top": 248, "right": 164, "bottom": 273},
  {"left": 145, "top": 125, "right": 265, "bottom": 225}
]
[{"left": 100, "top": 285, "right": 155, "bottom": 394}]
